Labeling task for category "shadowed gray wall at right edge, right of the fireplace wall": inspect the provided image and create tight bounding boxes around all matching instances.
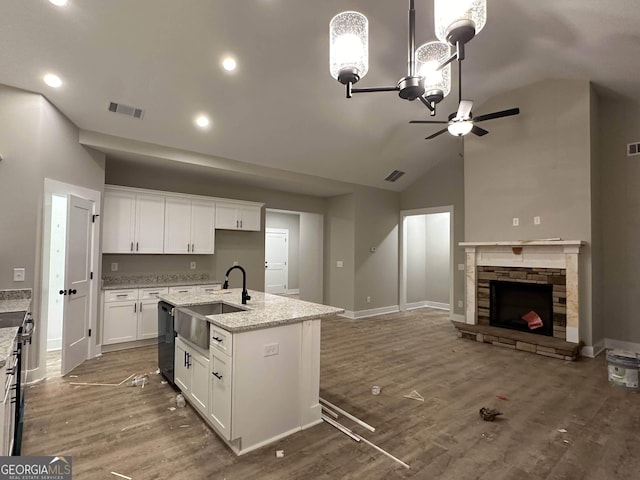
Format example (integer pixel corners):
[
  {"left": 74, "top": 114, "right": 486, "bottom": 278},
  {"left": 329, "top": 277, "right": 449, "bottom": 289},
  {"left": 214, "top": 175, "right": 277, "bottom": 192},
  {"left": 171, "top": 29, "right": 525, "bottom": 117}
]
[{"left": 600, "top": 99, "right": 640, "bottom": 344}]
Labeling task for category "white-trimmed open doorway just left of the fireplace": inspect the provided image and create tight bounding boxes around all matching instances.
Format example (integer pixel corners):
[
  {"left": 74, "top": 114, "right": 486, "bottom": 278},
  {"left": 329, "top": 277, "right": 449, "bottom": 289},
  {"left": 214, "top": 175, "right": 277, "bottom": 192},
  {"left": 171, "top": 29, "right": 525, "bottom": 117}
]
[{"left": 400, "top": 206, "right": 454, "bottom": 311}]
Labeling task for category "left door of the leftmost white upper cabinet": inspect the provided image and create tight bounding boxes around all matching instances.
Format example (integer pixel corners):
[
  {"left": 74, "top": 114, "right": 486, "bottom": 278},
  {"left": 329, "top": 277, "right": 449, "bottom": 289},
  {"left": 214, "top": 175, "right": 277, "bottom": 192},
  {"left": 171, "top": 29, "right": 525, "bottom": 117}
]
[{"left": 102, "top": 190, "right": 136, "bottom": 253}]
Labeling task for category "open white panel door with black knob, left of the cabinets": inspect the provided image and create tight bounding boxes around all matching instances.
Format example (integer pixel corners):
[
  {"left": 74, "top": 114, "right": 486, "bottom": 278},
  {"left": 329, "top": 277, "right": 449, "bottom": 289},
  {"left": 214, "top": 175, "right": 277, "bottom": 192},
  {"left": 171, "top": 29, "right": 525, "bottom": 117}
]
[{"left": 62, "top": 195, "right": 93, "bottom": 375}]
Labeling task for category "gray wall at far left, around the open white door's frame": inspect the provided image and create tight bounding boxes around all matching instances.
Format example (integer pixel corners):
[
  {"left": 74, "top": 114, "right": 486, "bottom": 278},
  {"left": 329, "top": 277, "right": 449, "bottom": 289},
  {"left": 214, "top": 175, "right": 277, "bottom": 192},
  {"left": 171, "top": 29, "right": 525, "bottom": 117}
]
[{"left": 0, "top": 85, "right": 104, "bottom": 369}]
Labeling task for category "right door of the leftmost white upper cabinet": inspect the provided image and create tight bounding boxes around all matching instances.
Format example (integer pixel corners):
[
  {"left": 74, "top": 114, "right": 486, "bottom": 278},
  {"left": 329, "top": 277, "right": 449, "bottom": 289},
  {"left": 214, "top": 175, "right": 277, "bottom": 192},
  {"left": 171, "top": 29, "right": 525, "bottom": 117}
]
[{"left": 135, "top": 195, "right": 164, "bottom": 253}]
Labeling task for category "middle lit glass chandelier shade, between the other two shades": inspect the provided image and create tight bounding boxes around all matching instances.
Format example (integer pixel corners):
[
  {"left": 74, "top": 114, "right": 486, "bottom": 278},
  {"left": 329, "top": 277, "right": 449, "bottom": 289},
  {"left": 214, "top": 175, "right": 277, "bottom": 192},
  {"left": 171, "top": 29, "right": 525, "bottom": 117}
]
[{"left": 416, "top": 42, "right": 451, "bottom": 103}]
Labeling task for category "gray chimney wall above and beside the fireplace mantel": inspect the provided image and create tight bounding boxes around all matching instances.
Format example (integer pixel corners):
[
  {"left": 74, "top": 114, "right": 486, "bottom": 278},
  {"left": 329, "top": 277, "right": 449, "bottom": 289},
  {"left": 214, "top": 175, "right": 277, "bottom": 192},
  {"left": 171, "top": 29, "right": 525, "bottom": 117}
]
[{"left": 465, "top": 80, "right": 602, "bottom": 345}]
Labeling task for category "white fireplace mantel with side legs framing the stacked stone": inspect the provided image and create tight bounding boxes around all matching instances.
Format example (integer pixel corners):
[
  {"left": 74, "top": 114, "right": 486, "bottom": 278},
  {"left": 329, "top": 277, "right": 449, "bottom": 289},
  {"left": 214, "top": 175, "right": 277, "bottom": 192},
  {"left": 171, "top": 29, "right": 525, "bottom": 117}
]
[{"left": 460, "top": 240, "right": 585, "bottom": 343}]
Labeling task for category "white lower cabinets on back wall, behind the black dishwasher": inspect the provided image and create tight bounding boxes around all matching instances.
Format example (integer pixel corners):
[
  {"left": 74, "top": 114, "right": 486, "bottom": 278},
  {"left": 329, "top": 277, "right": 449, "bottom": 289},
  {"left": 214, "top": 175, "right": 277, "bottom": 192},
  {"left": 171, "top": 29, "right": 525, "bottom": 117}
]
[{"left": 102, "top": 287, "right": 168, "bottom": 345}]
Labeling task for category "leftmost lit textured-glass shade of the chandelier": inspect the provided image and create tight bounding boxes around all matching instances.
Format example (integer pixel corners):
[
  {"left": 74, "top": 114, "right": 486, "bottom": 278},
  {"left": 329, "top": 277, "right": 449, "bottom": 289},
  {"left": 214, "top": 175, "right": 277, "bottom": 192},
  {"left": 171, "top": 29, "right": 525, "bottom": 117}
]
[{"left": 329, "top": 12, "right": 369, "bottom": 84}]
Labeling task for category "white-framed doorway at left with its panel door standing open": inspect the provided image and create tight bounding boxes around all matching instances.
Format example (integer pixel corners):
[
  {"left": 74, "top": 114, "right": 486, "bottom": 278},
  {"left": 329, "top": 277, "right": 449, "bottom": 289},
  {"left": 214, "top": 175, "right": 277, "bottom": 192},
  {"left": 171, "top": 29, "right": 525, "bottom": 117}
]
[{"left": 38, "top": 178, "right": 100, "bottom": 380}]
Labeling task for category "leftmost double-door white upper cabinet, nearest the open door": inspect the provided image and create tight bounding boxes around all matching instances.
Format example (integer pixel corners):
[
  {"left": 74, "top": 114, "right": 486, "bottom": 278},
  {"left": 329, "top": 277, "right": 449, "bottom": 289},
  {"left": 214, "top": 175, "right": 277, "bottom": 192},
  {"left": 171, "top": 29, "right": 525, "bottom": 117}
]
[{"left": 102, "top": 188, "right": 165, "bottom": 253}]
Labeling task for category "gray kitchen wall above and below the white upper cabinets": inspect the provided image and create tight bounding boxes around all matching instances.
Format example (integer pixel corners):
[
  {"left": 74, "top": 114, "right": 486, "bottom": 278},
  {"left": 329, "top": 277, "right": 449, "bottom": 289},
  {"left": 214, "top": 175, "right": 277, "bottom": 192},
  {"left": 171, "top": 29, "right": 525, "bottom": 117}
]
[{"left": 104, "top": 158, "right": 326, "bottom": 291}]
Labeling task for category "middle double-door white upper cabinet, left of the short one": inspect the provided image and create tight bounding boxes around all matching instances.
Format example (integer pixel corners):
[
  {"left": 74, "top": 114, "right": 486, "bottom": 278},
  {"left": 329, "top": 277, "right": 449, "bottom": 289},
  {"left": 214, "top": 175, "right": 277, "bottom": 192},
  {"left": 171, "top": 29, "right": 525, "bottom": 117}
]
[{"left": 164, "top": 197, "right": 216, "bottom": 254}]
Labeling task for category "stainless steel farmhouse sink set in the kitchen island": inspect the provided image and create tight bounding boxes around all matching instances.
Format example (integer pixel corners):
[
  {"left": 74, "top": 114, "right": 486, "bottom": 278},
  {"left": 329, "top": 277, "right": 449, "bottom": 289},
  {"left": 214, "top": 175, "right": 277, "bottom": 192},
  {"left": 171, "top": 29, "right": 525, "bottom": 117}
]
[{"left": 175, "top": 302, "right": 245, "bottom": 350}]
